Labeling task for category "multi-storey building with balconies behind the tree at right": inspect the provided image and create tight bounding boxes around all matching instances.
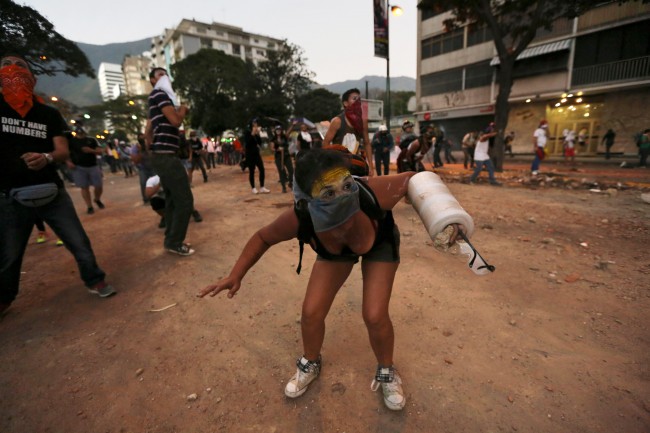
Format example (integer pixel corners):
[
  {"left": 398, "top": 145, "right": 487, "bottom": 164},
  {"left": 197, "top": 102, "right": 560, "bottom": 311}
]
[{"left": 415, "top": 2, "right": 650, "bottom": 154}]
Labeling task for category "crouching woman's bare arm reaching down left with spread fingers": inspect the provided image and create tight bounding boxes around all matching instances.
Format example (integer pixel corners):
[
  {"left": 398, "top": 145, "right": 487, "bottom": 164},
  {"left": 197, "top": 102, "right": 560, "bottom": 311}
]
[{"left": 198, "top": 209, "right": 298, "bottom": 298}]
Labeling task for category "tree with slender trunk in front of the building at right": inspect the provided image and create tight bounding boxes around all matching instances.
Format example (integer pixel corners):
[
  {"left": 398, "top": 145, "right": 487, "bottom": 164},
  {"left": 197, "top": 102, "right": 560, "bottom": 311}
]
[{"left": 418, "top": 0, "right": 647, "bottom": 171}]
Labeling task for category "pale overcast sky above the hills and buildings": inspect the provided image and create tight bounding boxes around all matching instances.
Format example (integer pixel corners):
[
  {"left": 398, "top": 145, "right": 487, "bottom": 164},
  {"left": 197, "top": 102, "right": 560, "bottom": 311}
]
[{"left": 20, "top": 0, "right": 417, "bottom": 84}]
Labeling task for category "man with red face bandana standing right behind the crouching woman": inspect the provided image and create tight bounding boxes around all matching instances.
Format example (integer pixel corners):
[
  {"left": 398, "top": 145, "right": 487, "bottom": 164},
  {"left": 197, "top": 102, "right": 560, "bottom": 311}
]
[{"left": 323, "top": 89, "right": 374, "bottom": 176}]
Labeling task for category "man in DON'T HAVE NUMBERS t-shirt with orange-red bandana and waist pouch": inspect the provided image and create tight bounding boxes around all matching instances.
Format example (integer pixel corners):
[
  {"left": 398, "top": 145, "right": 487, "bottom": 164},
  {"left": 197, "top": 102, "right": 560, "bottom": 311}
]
[{"left": 0, "top": 55, "right": 116, "bottom": 313}]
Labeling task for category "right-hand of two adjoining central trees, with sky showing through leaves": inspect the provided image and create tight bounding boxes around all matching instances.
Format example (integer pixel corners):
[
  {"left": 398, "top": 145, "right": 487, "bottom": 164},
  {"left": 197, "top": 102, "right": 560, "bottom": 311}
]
[{"left": 255, "top": 40, "right": 314, "bottom": 120}]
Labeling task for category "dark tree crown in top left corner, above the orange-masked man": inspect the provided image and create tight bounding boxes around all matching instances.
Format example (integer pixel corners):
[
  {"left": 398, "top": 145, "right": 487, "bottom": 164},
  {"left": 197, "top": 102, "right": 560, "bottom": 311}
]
[{"left": 0, "top": 0, "right": 95, "bottom": 78}]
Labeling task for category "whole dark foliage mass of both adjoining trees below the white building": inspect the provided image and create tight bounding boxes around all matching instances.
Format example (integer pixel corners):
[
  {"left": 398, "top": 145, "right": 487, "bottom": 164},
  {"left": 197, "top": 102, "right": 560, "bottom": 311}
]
[{"left": 171, "top": 41, "right": 312, "bottom": 135}]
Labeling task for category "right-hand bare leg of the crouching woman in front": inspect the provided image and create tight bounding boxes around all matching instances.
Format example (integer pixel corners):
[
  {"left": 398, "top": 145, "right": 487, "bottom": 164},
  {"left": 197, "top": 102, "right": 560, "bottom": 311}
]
[{"left": 361, "top": 261, "right": 399, "bottom": 367}]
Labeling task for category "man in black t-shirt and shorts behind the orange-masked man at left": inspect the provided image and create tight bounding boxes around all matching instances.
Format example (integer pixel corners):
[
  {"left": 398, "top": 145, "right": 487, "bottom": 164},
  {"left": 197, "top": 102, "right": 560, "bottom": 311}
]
[{"left": 68, "top": 128, "right": 104, "bottom": 214}]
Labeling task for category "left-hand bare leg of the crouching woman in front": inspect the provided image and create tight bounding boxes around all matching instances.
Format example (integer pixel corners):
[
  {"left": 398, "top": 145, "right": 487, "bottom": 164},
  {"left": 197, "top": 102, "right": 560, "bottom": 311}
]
[{"left": 300, "top": 260, "right": 353, "bottom": 361}]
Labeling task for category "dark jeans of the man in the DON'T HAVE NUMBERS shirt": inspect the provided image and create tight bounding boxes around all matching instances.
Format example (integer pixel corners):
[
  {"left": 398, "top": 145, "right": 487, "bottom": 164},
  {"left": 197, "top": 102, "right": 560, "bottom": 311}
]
[{"left": 0, "top": 188, "right": 106, "bottom": 304}]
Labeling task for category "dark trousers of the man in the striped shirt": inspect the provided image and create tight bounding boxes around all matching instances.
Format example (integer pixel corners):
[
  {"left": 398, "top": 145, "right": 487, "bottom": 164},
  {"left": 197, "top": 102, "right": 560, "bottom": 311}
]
[{"left": 151, "top": 153, "right": 194, "bottom": 249}]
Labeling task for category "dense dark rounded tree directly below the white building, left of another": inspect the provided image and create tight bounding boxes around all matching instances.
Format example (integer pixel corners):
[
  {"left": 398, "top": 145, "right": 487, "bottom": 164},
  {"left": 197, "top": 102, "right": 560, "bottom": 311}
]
[{"left": 171, "top": 49, "right": 258, "bottom": 135}]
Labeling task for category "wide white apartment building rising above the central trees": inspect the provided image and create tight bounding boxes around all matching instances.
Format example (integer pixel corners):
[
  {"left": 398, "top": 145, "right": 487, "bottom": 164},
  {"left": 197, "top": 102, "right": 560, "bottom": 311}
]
[{"left": 151, "top": 19, "right": 282, "bottom": 74}]
